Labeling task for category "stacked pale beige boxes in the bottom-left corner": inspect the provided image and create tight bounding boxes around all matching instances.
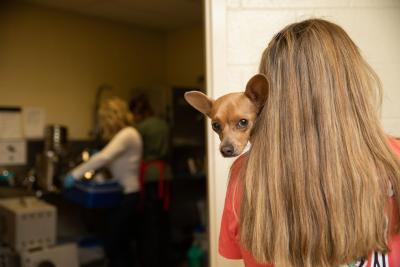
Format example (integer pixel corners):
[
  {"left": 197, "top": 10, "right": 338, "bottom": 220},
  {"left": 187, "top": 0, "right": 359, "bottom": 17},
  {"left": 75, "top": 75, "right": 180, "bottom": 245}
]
[{"left": 0, "top": 197, "right": 79, "bottom": 267}]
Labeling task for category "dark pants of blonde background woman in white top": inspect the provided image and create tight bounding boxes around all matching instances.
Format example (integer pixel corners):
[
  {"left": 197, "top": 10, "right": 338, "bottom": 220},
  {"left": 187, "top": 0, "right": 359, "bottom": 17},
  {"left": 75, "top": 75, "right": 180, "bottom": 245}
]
[{"left": 105, "top": 193, "right": 140, "bottom": 267}]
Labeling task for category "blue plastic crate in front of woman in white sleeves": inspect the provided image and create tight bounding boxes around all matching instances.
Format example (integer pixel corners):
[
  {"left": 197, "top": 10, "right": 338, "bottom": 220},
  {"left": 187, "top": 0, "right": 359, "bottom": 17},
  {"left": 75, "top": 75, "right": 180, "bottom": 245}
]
[{"left": 63, "top": 180, "right": 122, "bottom": 208}]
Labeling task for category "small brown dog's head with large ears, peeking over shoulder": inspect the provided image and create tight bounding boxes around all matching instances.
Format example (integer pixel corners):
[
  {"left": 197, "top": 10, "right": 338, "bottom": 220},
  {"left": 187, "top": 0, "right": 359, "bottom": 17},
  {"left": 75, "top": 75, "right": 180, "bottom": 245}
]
[{"left": 185, "top": 74, "right": 268, "bottom": 157}]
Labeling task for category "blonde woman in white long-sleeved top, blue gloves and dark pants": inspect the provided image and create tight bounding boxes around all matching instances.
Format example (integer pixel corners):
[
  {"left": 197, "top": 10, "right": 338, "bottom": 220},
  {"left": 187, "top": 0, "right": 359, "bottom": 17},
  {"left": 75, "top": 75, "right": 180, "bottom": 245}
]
[{"left": 64, "top": 98, "right": 143, "bottom": 267}]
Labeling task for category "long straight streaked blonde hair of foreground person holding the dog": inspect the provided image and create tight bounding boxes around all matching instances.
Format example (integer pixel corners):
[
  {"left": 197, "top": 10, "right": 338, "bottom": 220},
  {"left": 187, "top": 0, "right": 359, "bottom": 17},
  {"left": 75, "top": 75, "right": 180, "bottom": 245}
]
[{"left": 239, "top": 19, "right": 400, "bottom": 267}]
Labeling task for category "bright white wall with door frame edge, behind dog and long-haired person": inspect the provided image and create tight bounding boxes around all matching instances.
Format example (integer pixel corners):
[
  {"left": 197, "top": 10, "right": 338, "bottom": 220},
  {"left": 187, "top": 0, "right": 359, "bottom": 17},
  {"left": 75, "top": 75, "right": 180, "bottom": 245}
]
[{"left": 206, "top": 0, "right": 400, "bottom": 267}]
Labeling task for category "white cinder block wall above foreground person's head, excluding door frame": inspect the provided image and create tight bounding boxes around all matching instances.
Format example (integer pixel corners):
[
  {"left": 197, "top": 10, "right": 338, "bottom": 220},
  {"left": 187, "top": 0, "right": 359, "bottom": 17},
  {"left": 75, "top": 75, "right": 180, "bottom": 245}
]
[{"left": 226, "top": 0, "right": 400, "bottom": 136}]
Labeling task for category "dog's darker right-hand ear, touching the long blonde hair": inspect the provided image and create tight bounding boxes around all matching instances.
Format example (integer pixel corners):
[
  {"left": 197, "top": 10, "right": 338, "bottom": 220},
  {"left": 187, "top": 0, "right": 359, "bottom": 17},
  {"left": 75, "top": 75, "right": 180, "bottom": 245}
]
[{"left": 244, "top": 74, "right": 269, "bottom": 110}]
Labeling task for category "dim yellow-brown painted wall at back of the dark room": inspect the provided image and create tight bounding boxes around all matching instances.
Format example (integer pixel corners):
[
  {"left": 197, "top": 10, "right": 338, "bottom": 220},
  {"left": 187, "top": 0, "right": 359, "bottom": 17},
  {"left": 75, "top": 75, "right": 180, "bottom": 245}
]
[{"left": 0, "top": 1, "right": 165, "bottom": 139}]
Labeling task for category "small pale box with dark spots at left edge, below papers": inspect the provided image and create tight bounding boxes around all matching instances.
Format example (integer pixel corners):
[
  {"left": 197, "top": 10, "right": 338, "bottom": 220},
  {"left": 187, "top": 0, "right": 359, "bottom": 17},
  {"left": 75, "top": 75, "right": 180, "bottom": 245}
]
[{"left": 0, "top": 139, "right": 27, "bottom": 166}]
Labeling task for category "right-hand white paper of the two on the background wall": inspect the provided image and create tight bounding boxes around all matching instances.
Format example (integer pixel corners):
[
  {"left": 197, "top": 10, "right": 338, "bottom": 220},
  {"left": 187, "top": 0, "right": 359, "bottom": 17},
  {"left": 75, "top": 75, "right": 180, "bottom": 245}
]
[{"left": 22, "top": 107, "right": 46, "bottom": 138}]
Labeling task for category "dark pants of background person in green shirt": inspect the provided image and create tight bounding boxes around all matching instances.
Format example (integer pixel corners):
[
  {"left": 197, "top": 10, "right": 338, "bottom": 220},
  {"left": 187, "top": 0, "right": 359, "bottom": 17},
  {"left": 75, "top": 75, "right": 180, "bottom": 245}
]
[{"left": 139, "top": 182, "right": 170, "bottom": 267}]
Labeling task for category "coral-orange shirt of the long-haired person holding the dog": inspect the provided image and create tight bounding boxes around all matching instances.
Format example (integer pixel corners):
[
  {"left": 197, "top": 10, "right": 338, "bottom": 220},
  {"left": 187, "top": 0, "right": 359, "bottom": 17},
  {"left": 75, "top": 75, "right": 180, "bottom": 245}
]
[{"left": 219, "top": 139, "right": 400, "bottom": 267}]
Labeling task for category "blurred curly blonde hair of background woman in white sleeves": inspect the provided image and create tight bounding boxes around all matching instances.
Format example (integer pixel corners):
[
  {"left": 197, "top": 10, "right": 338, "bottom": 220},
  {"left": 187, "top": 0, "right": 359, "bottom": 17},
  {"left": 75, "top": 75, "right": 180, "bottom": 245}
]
[{"left": 99, "top": 97, "right": 133, "bottom": 140}]
